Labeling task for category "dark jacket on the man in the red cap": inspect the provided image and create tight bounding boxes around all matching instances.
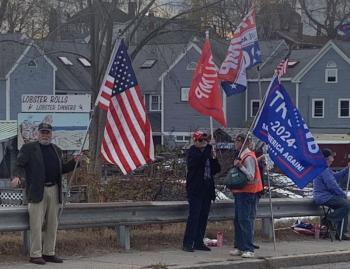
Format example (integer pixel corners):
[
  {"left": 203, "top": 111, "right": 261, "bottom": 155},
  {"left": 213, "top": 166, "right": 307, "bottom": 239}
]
[{"left": 186, "top": 145, "right": 220, "bottom": 200}]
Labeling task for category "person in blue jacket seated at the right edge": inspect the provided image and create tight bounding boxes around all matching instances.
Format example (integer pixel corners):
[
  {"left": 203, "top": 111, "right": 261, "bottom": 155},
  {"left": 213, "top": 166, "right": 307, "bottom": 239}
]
[{"left": 313, "top": 148, "right": 350, "bottom": 240}]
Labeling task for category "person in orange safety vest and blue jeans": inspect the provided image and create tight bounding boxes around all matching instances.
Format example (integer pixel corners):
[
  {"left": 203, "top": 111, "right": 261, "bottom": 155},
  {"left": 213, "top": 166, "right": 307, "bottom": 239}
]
[{"left": 230, "top": 134, "right": 263, "bottom": 258}]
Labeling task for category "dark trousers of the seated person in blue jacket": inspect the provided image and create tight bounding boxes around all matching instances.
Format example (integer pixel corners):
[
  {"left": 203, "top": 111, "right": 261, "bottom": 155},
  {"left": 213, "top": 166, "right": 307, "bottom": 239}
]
[{"left": 324, "top": 197, "right": 350, "bottom": 234}]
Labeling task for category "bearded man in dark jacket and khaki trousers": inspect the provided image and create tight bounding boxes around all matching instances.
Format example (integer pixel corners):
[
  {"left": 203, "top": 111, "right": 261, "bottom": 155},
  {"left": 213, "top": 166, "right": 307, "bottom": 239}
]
[{"left": 11, "top": 123, "right": 79, "bottom": 264}]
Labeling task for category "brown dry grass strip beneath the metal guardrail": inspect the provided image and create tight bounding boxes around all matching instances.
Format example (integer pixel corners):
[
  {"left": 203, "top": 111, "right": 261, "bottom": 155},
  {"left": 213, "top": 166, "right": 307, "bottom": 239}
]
[{"left": 0, "top": 220, "right": 313, "bottom": 262}]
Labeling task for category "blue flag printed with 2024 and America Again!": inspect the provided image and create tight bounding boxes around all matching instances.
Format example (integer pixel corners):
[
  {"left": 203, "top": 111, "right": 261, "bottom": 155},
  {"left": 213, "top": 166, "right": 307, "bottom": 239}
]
[{"left": 253, "top": 77, "right": 327, "bottom": 189}]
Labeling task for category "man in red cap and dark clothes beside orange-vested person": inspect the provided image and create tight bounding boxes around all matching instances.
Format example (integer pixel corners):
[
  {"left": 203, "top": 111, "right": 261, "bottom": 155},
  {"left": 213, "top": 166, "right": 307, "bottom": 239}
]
[{"left": 182, "top": 131, "right": 220, "bottom": 252}]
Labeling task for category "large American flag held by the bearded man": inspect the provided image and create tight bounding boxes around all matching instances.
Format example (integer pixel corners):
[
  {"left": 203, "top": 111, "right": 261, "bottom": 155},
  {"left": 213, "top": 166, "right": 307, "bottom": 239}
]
[{"left": 97, "top": 40, "right": 154, "bottom": 174}]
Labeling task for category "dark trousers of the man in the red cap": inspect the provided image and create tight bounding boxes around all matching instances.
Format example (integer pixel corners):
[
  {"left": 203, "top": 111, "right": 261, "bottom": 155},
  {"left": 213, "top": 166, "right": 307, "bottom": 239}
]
[{"left": 183, "top": 195, "right": 211, "bottom": 248}]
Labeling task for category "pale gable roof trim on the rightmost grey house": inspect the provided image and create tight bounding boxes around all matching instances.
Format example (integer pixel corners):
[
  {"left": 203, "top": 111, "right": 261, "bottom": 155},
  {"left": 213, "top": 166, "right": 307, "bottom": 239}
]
[{"left": 292, "top": 40, "right": 350, "bottom": 82}]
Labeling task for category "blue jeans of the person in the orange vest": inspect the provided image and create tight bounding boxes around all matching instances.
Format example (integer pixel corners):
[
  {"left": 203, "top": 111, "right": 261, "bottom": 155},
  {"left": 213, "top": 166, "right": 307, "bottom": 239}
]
[{"left": 234, "top": 193, "right": 258, "bottom": 252}]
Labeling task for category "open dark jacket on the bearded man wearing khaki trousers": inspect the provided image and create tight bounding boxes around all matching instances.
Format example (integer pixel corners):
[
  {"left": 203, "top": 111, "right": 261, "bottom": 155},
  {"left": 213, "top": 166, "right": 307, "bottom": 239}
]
[{"left": 13, "top": 142, "right": 75, "bottom": 203}]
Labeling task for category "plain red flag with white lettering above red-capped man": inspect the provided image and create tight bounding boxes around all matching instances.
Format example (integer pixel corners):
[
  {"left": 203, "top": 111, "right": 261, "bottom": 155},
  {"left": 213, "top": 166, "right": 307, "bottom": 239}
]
[{"left": 189, "top": 39, "right": 226, "bottom": 127}]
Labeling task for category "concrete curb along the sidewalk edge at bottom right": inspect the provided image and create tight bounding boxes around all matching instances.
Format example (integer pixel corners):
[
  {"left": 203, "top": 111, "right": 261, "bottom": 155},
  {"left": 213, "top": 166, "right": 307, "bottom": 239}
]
[{"left": 172, "top": 251, "right": 350, "bottom": 269}]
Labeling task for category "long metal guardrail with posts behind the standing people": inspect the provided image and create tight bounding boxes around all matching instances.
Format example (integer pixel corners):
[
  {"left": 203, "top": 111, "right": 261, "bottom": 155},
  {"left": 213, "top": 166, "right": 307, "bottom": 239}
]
[{"left": 0, "top": 198, "right": 323, "bottom": 249}]
